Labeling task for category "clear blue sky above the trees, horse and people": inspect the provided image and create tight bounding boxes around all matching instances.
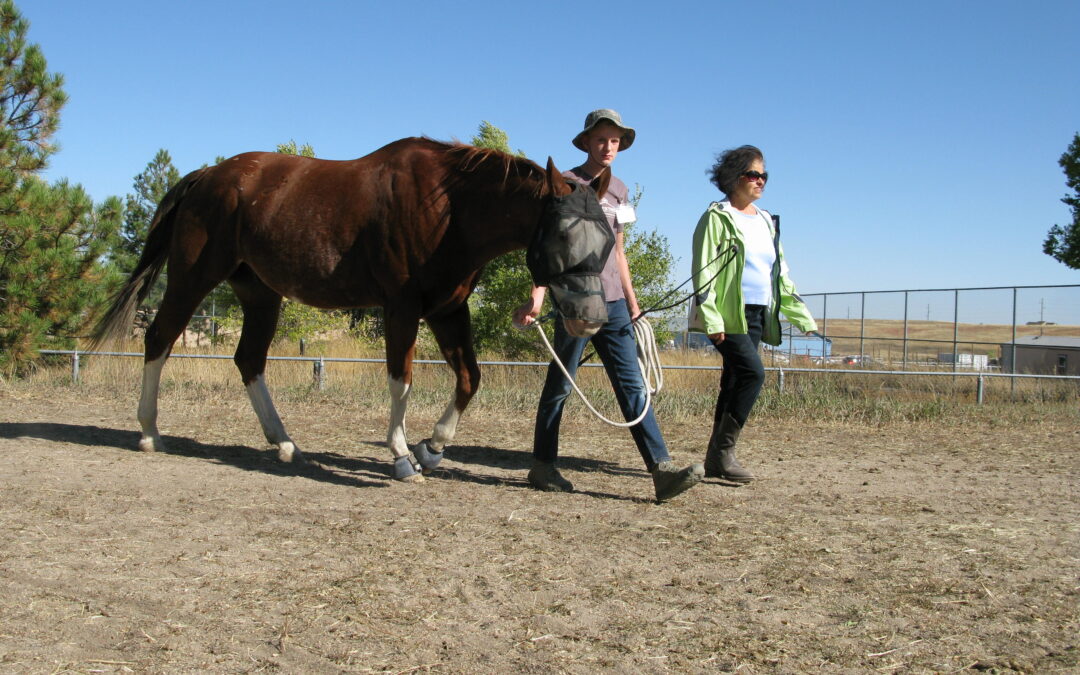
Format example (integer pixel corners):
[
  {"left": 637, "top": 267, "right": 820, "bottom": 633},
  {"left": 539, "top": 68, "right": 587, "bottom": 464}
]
[{"left": 18, "top": 0, "right": 1080, "bottom": 324}]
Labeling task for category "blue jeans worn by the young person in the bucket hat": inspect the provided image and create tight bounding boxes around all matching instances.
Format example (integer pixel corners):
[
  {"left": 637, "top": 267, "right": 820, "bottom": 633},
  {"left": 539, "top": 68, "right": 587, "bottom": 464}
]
[{"left": 532, "top": 300, "right": 671, "bottom": 471}]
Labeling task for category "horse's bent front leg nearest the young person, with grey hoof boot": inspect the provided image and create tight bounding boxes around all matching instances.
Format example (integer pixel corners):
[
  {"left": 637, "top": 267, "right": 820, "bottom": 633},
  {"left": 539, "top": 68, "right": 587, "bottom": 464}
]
[{"left": 413, "top": 305, "right": 480, "bottom": 472}]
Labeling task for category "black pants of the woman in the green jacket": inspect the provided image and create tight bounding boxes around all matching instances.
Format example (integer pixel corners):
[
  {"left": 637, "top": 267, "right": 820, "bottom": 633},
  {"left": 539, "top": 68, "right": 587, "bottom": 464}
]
[{"left": 713, "top": 305, "right": 768, "bottom": 429}]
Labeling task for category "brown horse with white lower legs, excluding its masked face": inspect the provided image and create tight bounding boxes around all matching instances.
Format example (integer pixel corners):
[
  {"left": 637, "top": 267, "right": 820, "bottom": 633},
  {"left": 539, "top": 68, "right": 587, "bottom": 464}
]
[{"left": 94, "top": 138, "right": 607, "bottom": 481}]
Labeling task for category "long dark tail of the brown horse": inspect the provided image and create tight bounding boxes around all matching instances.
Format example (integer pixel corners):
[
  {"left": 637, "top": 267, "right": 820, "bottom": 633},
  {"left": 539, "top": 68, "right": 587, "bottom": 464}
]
[{"left": 90, "top": 167, "right": 206, "bottom": 350}]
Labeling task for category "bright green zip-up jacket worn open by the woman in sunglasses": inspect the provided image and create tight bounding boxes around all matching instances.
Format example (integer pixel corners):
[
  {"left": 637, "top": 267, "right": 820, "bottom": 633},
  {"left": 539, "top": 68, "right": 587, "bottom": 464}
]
[{"left": 690, "top": 201, "right": 818, "bottom": 346}]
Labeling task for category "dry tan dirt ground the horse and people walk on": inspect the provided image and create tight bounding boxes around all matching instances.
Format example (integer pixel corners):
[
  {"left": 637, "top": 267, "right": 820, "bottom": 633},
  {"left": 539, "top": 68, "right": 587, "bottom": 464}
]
[{"left": 0, "top": 387, "right": 1080, "bottom": 673}]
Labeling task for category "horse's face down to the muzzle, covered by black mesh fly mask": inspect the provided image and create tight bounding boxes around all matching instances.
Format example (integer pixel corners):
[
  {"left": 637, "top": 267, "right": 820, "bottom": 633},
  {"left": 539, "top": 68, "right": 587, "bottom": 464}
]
[{"left": 525, "top": 180, "right": 615, "bottom": 337}]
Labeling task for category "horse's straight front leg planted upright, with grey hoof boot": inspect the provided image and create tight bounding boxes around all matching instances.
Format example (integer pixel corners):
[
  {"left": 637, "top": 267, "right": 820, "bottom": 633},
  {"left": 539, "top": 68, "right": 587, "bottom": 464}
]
[{"left": 386, "top": 300, "right": 423, "bottom": 483}]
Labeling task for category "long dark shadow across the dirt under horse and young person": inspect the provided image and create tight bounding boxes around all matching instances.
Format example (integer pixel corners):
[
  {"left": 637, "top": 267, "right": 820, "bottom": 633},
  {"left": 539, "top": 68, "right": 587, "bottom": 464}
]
[{"left": 0, "top": 422, "right": 648, "bottom": 501}]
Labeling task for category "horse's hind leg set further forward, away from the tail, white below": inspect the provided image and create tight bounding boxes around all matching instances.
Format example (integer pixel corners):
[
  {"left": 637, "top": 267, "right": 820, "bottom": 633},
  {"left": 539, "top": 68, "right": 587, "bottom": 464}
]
[{"left": 229, "top": 267, "right": 303, "bottom": 463}]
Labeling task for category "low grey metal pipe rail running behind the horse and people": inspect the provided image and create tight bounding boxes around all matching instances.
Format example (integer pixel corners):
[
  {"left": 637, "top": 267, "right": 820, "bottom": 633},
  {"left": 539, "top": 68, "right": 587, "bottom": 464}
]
[{"left": 38, "top": 349, "right": 1080, "bottom": 381}]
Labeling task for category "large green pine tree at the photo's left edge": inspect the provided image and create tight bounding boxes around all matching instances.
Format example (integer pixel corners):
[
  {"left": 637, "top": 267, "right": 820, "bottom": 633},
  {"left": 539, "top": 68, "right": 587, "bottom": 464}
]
[{"left": 0, "top": 0, "right": 123, "bottom": 374}]
